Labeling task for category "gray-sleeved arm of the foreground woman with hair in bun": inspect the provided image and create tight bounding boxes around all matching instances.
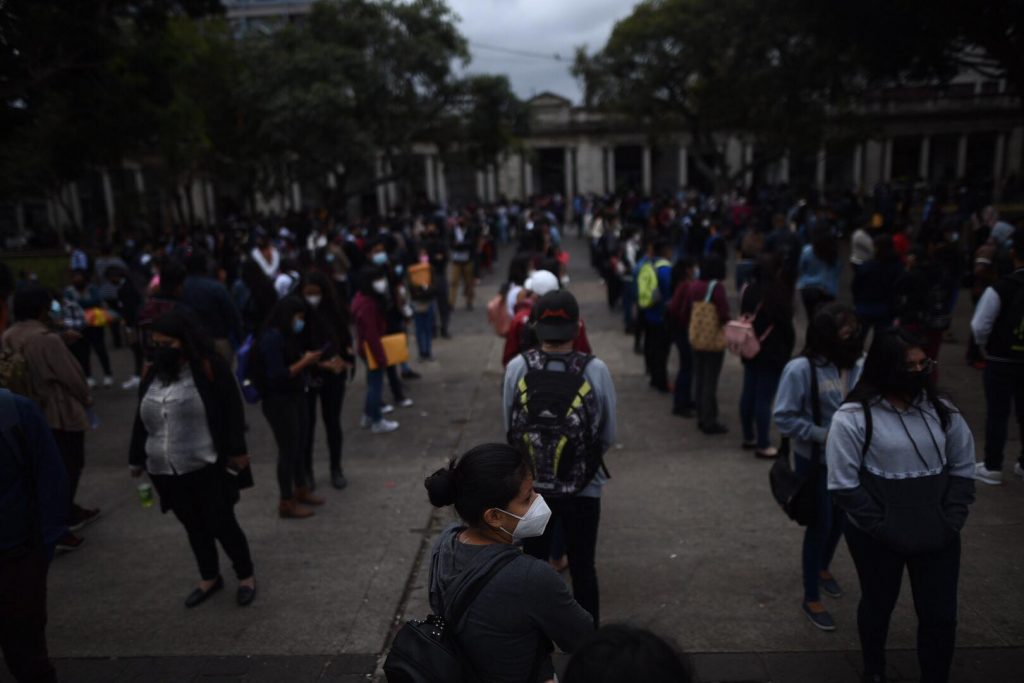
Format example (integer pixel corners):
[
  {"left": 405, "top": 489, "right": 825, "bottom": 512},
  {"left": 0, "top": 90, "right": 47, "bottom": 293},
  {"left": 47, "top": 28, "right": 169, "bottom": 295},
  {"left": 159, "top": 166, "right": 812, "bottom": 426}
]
[{"left": 517, "top": 560, "right": 594, "bottom": 653}]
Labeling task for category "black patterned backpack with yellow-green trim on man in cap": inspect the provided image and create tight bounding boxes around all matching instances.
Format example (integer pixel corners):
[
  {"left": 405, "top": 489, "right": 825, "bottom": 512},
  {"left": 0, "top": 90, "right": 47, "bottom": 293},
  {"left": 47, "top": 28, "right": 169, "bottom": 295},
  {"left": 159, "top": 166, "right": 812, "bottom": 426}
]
[{"left": 508, "top": 349, "right": 607, "bottom": 498}]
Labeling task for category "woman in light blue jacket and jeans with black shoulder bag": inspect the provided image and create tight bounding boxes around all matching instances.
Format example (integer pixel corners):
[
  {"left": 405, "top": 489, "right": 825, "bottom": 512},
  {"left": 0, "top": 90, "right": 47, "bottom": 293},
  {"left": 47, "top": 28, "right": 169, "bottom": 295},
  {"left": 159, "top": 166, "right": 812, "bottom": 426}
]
[{"left": 774, "top": 303, "right": 862, "bottom": 631}]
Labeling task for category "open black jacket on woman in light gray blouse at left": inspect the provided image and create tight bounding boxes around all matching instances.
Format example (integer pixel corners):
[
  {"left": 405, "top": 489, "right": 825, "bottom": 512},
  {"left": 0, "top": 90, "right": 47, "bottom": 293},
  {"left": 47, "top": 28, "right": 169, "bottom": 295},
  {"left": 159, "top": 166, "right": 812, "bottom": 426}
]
[{"left": 128, "top": 355, "right": 249, "bottom": 467}]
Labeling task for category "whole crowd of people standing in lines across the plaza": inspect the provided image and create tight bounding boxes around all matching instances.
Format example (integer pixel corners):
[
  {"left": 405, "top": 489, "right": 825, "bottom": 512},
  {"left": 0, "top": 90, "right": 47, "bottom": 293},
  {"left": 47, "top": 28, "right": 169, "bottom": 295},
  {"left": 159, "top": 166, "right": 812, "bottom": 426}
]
[{"left": 0, "top": 181, "right": 1024, "bottom": 681}]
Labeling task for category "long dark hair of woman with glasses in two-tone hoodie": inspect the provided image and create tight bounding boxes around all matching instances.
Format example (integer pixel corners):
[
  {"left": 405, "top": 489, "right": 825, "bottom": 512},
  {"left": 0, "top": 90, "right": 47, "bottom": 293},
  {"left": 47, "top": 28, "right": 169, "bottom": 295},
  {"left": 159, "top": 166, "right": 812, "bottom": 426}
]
[{"left": 846, "top": 328, "right": 952, "bottom": 429}]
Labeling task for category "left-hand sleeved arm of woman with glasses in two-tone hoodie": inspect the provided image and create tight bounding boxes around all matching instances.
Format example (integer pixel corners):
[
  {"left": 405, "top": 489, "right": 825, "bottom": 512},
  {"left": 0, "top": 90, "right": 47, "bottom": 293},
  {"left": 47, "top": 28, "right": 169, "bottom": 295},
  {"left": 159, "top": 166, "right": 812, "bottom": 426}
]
[{"left": 825, "top": 409, "right": 885, "bottom": 532}]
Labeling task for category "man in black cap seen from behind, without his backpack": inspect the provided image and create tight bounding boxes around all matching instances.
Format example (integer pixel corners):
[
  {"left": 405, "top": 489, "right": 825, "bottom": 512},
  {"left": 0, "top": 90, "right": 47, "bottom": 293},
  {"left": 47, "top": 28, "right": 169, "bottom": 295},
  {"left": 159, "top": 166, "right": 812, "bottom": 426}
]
[{"left": 503, "top": 288, "right": 615, "bottom": 625}]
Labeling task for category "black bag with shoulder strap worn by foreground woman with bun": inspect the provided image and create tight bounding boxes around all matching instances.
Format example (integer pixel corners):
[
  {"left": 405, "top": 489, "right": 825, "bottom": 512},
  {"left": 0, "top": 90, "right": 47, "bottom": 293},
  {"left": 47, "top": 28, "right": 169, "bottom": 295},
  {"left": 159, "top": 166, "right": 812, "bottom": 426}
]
[{"left": 384, "top": 552, "right": 519, "bottom": 683}]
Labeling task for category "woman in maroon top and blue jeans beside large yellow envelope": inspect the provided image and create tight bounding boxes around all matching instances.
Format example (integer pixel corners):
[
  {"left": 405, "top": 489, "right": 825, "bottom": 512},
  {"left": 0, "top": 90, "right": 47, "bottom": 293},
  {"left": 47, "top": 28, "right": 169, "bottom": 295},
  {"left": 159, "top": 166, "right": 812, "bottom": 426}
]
[{"left": 352, "top": 266, "right": 398, "bottom": 434}]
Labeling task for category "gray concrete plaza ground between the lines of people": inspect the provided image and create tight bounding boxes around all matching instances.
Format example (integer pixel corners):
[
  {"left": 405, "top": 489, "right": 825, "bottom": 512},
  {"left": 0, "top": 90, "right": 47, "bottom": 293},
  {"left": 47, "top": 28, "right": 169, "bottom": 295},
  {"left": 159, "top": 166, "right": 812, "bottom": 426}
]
[{"left": 0, "top": 238, "right": 1024, "bottom": 683}]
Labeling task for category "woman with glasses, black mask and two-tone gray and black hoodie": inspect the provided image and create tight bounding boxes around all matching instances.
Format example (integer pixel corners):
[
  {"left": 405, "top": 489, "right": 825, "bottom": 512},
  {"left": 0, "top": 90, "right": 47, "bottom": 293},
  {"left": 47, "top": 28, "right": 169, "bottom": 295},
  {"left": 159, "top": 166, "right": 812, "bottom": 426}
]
[{"left": 825, "top": 329, "right": 975, "bottom": 683}]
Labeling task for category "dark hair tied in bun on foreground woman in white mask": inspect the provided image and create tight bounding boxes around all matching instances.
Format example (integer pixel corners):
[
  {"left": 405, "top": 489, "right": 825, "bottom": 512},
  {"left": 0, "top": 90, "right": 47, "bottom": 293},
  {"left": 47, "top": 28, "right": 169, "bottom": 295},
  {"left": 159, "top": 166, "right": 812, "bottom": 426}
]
[{"left": 423, "top": 443, "right": 534, "bottom": 526}]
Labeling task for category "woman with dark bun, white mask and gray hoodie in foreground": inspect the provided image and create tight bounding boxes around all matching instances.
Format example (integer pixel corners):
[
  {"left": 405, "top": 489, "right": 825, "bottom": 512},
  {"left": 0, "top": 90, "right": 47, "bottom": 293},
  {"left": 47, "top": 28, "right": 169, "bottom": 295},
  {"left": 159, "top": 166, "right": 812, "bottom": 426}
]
[{"left": 425, "top": 443, "right": 594, "bottom": 683}]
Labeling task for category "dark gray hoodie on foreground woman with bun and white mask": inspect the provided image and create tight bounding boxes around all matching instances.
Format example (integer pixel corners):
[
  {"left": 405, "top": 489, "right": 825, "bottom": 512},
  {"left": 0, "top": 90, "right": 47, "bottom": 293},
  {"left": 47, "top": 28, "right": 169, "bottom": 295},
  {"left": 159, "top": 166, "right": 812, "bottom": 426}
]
[{"left": 430, "top": 523, "right": 594, "bottom": 683}]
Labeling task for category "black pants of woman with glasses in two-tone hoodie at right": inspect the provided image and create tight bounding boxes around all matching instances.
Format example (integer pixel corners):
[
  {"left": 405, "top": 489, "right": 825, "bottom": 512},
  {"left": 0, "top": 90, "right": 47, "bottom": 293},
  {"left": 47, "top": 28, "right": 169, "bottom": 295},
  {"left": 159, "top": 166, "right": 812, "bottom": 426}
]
[{"left": 846, "top": 523, "right": 961, "bottom": 683}]
